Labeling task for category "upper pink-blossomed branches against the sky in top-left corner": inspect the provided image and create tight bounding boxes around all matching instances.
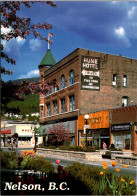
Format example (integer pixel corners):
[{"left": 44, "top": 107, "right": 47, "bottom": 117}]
[{"left": 0, "top": 1, "right": 56, "bottom": 74}]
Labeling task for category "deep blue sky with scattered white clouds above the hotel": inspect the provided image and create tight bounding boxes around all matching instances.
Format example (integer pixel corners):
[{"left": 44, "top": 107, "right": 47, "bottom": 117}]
[{"left": 1, "top": 1, "right": 137, "bottom": 81}]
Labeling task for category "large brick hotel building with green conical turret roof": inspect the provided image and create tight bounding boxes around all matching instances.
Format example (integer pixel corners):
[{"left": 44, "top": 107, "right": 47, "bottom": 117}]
[{"left": 39, "top": 48, "right": 137, "bottom": 145}]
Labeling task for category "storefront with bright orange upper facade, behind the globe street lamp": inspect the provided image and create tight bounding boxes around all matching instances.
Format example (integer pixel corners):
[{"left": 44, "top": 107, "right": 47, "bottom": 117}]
[{"left": 78, "top": 110, "right": 110, "bottom": 148}]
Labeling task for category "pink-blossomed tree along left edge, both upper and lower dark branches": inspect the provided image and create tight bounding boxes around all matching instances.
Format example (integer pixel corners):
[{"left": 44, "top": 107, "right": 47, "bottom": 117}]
[{"left": 0, "top": 1, "right": 56, "bottom": 115}]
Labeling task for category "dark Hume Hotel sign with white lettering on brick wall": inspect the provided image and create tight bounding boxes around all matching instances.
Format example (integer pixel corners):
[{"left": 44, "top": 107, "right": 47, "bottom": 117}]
[{"left": 81, "top": 56, "right": 100, "bottom": 91}]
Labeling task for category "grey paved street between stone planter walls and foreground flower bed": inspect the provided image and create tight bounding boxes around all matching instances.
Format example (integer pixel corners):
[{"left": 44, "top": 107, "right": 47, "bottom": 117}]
[{"left": 1, "top": 148, "right": 137, "bottom": 185}]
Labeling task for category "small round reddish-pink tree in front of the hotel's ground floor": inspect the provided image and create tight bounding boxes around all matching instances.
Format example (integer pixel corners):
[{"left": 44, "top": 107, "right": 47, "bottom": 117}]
[{"left": 48, "top": 123, "right": 71, "bottom": 146}]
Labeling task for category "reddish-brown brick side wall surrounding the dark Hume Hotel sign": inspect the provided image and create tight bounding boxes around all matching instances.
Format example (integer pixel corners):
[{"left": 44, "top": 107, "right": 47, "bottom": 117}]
[{"left": 79, "top": 49, "right": 137, "bottom": 114}]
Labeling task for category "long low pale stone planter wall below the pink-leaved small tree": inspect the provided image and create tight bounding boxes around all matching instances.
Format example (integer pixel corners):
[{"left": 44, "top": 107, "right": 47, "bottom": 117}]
[{"left": 36, "top": 148, "right": 102, "bottom": 161}]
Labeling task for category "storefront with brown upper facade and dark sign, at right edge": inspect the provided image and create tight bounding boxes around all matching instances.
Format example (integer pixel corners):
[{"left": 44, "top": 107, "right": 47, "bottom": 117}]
[{"left": 110, "top": 105, "right": 137, "bottom": 153}]
